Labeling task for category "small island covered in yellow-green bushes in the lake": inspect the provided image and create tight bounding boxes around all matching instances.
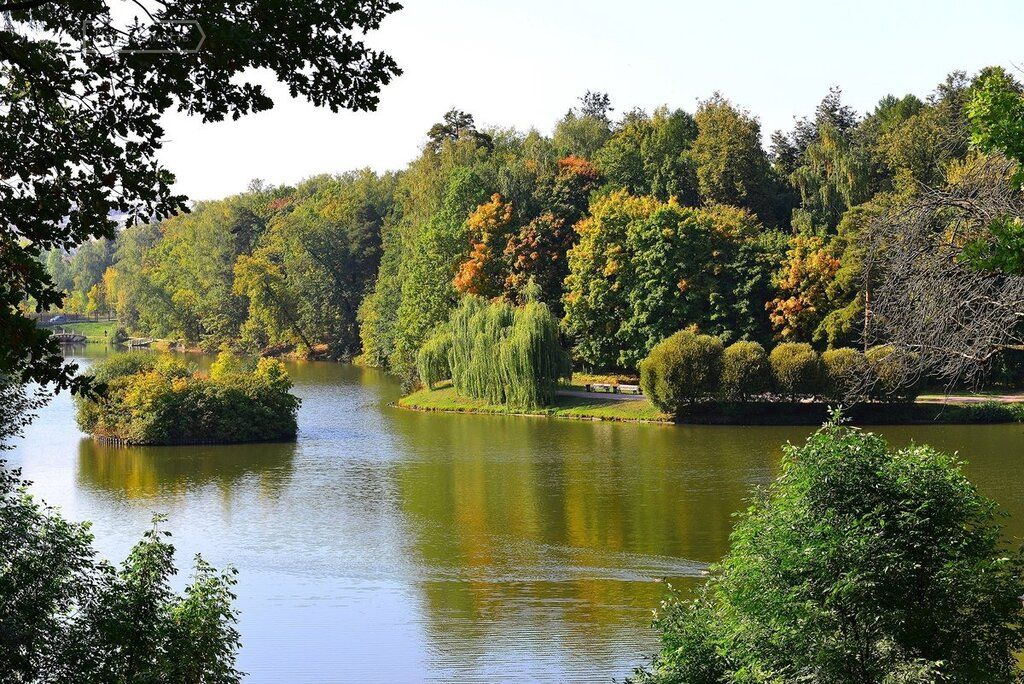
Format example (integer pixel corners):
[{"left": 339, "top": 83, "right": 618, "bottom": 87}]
[{"left": 76, "top": 351, "right": 299, "bottom": 444}]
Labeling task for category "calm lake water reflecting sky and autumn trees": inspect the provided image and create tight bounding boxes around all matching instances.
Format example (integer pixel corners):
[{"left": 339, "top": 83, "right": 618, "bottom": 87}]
[{"left": 6, "top": 349, "right": 1024, "bottom": 683}]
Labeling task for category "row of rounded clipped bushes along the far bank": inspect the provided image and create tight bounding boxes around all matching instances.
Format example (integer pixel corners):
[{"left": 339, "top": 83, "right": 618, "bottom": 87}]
[{"left": 640, "top": 330, "right": 916, "bottom": 413}]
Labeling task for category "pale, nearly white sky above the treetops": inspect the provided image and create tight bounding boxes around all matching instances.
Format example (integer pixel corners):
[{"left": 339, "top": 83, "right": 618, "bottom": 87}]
[{"left": 162, "top": 0, "right": 1024, "bottom": 200}]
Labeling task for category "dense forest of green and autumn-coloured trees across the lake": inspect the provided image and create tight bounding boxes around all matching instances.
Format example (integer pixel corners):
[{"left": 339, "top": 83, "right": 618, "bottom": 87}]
[{"left": 45, "top": 68, "right": 1018, "bottom": 389}]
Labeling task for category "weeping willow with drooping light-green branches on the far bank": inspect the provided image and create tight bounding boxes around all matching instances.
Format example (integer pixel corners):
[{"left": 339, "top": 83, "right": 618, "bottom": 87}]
[{"left": 417, "top": 296, "right": 570, "bottom": 409}]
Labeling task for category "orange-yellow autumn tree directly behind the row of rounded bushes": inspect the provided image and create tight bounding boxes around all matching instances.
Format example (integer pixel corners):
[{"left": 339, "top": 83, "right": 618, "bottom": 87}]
[{"left": 765, "top": 234, "right": 842, "bottom": 341}]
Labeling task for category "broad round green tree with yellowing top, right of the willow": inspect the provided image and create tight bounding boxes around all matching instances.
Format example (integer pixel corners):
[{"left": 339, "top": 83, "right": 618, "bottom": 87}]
[{"left": 563, "top": 190, "right": 776, "bottom": 370}]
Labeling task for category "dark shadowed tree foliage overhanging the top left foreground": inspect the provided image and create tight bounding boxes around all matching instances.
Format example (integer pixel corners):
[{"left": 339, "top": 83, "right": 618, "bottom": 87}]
[{"left": 0, "top": 0, "right": 400, "bottom": 387}]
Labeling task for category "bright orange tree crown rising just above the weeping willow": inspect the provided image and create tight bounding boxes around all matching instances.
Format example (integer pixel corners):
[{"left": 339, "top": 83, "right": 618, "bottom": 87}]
[{"left": 453, "top": 193, "right": 512, "bottom": 297}]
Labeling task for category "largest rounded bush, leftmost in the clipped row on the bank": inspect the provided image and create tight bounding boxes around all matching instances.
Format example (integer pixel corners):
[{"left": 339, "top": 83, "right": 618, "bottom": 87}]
[{"left": 640, "top": 330, "right": 723, "bottom": 415}]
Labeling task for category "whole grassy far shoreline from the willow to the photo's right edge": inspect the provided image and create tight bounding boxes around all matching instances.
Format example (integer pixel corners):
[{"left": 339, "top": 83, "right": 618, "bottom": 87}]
[{"left": 398, "top": 387, "right": 1024, "bottom": 425}]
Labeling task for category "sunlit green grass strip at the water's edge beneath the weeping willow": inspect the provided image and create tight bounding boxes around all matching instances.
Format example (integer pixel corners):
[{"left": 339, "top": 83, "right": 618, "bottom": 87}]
[{"left": 398, "top": 387, "right": 672, "bottom": 423}]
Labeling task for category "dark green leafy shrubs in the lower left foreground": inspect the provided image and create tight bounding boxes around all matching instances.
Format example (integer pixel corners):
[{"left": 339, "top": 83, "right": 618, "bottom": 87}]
[{"left": 0, "top": 461, "right": 242, "bottom": 684}]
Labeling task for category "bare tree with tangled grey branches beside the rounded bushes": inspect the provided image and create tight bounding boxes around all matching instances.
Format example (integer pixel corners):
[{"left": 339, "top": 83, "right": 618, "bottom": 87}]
[{"left": 865, "top": 156, "right": 1024, "bottom": 387}]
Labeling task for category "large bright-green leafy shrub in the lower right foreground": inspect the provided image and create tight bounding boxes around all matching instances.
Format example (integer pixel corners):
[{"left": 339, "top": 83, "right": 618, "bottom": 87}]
[{"left": 639, "top": 424, "right": 1024, "bottom": 684}]
